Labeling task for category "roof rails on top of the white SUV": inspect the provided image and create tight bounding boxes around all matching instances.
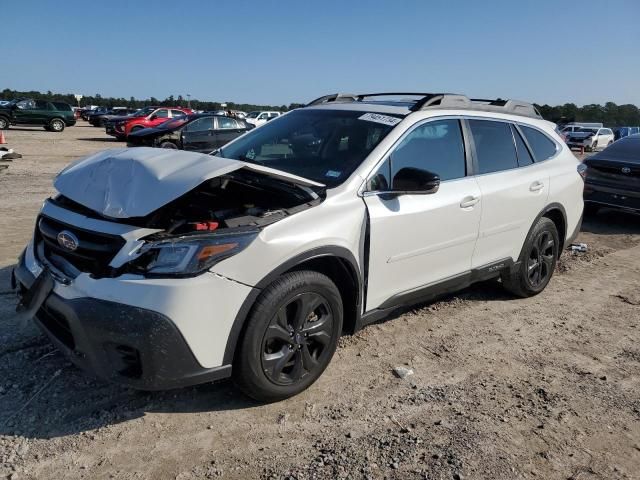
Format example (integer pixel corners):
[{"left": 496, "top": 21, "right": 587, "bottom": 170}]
[{"left": 307, "top": 92, "right": 542, "bottom": 118}]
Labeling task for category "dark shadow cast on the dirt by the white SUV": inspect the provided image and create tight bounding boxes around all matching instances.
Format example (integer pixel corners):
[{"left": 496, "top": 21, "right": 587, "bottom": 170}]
[{"left": 0, "top": 258, "right": 510, "bottom": 439}]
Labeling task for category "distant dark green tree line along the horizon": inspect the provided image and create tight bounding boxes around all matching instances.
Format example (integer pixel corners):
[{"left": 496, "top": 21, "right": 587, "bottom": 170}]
[{"left": 0, "top": 88, "right": 640, "bottom": 127}]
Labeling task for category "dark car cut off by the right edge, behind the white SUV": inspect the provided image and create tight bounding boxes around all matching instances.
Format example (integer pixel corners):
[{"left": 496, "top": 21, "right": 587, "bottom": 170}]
[{"left": 583, "top": 134, "right": 640, "bottom": 213}]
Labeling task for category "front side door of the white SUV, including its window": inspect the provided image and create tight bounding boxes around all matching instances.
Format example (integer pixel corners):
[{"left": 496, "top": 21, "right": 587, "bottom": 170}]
[{"left": 364, "top": 119, "right": 481, "bottom": 310}]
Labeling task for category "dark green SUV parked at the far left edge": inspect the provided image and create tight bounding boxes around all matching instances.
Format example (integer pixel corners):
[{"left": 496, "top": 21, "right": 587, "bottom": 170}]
[{"left": 0, "top": 99, "right": 76, "bottom": 132}]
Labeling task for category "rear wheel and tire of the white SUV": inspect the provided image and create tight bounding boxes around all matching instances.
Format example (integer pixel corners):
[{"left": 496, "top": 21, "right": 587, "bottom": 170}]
[{"left": 502, "top": 217, "right": 560, "bottom": 297}]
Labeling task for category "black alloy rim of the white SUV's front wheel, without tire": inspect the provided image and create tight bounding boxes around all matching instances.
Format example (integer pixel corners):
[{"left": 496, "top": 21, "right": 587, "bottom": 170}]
[{"left": 262, "top": 292, "right": 334, "bottom": 385}]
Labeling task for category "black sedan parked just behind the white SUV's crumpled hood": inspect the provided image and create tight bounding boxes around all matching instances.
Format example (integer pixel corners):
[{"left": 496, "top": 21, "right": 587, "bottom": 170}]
[{"left": 127, "top": 114, "right": 255, "bottom": 153}]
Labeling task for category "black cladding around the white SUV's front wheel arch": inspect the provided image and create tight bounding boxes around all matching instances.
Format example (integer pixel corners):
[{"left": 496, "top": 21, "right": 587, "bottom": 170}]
[{"left": 223, "top": 246, "right": 362, "bottom": 365}]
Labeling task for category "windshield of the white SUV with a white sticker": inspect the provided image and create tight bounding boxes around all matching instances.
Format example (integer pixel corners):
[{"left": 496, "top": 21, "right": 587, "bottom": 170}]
[{"left": 219, "top": 109, "right": 402, "bottom": 187}]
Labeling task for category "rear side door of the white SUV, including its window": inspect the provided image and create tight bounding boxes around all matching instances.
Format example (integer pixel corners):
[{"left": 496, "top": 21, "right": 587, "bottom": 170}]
[{"left": 467, "top": 118, "right": 555, "bottom": 268}]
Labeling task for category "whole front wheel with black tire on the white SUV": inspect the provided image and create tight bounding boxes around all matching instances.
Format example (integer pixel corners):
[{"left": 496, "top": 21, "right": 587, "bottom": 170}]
[{"left": 233, "top": 271, "right": 343, "bottom": 402}]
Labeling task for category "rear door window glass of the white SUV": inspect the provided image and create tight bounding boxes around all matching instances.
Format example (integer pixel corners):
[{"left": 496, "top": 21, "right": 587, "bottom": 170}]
[{"left": 469, "top": 120, "right": 518, "bottom": 174}]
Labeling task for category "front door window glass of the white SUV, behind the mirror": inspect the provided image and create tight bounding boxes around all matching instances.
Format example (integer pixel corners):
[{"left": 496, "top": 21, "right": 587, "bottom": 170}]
[{"left": 384, "top": 120, "right": 466, "bottom": 181}]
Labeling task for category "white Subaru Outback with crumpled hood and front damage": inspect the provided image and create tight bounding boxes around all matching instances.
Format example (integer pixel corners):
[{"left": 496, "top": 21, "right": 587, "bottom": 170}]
[{"left": 13, "top": 94, "right": 583, "bottom": 401}]
